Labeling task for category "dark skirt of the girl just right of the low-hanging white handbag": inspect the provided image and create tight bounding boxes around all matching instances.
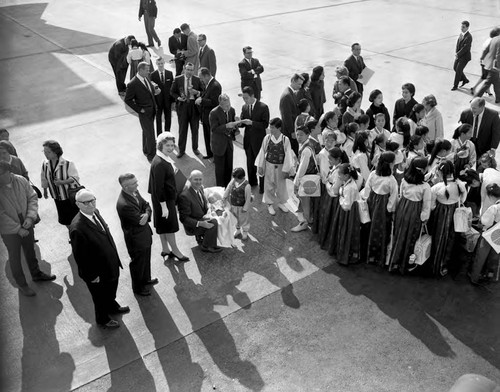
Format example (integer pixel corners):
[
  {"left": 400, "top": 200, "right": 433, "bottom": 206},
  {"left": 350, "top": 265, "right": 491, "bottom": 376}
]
[{"left": 426, "top": 202, "right": 458, "bottom": 276}]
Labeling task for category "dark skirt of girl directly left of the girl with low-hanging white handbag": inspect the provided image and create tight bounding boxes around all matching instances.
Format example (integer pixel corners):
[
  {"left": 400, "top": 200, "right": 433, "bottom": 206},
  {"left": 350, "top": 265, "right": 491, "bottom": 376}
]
[{"left": 367, "top": 191, "right": 392, "bottom": 266}]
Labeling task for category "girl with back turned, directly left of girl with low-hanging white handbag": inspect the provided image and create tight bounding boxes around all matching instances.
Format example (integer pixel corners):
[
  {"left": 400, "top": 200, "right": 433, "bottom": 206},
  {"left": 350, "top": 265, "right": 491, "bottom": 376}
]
[{"left": 361, "top": 151, "right": 398, "bottom": 266}]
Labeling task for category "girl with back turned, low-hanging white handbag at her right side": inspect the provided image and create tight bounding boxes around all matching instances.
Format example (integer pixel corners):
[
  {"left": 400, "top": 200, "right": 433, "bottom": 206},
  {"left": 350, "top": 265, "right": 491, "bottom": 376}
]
[{"left": 389, "top": 157, "right": 431, "bottom": 274}]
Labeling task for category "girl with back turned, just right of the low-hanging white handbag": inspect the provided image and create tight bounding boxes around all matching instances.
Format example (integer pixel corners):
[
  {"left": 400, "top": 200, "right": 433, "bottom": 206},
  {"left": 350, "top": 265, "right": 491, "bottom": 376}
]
[{"left": 429, "top": 160, "right": 467, "bottom": 276}]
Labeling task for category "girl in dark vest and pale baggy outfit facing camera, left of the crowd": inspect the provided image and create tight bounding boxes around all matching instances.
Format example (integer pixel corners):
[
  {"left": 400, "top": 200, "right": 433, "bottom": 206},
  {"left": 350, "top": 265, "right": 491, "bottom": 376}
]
[{"left": 255, "top": 117, "right": 296, "bottom": 215}]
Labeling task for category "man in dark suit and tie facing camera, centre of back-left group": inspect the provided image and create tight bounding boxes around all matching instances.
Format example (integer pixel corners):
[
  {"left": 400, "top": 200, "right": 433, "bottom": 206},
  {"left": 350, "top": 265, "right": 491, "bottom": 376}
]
[{"left": 170, "top": 63, "right": 203, "bottom": 158}]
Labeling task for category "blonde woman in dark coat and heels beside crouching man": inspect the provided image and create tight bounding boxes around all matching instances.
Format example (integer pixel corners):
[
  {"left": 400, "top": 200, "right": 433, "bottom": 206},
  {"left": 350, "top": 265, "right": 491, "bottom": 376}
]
[{"left": 148, "top": 132, "right": 189, "bottom": 261}]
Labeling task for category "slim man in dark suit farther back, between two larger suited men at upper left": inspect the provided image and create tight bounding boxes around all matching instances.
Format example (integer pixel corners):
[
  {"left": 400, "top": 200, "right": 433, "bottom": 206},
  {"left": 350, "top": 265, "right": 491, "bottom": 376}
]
[{"left": 151, "top": 57, "right": 174, "bottom": 135}]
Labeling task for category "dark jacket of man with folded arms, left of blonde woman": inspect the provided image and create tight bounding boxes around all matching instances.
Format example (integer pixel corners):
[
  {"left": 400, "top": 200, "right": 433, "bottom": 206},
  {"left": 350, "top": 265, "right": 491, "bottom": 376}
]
[{"left": 116, "top": 191, "right": 153, "bottom": 256}]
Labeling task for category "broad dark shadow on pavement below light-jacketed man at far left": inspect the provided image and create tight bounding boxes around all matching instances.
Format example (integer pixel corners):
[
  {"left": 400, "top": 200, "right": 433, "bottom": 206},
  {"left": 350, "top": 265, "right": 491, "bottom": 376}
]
[{"left": 19, "top": 282, "right": 75, "bottom": 392}]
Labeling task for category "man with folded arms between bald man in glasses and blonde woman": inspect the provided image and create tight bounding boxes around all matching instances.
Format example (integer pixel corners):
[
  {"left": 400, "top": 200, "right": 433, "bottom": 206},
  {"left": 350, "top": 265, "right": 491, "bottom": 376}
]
[{"left": 116, "top": 173, "right": 158, "bottom": 296}]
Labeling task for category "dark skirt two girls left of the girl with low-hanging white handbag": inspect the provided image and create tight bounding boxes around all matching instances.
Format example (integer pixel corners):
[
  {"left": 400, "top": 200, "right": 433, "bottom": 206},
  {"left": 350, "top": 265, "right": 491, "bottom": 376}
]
[{"left": 337, "top": 202, "right": 360, "bottom": 265}]
